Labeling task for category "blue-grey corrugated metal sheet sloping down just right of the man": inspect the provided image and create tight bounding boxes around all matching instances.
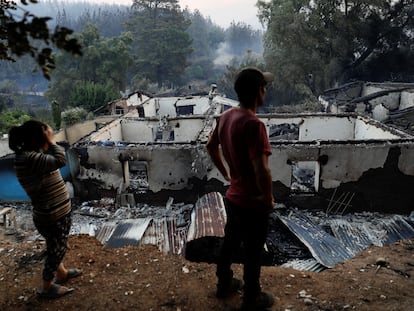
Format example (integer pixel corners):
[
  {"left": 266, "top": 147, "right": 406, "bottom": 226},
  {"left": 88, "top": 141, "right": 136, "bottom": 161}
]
[{"left": 279, "top": 212, "right": 353, "bottom": 268}]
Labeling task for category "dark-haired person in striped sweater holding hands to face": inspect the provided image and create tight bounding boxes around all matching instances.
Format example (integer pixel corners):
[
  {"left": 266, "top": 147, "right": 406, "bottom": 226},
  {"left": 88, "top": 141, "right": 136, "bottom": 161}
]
[{"left": 9, "top": 120, "right": 82, "bottom": 299}]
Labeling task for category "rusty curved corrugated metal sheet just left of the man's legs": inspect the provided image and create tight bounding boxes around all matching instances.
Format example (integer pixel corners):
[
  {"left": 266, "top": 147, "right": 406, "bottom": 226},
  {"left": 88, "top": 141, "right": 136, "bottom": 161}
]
[{"left": 187, "top": 192, "right": 226, "bottom": 242}]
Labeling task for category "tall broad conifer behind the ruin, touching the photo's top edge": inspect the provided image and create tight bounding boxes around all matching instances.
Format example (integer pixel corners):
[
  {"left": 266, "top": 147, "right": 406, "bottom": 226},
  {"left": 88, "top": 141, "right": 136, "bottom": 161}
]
[{"left": 128, "top": 0, "right": 192, "bottom": 87}]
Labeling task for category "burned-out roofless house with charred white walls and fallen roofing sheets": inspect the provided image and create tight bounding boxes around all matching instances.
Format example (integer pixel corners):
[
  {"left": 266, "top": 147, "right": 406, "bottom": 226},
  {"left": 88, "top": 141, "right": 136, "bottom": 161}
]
[{"left": 0, "top": 88, "right": 414, "bottom": 269}]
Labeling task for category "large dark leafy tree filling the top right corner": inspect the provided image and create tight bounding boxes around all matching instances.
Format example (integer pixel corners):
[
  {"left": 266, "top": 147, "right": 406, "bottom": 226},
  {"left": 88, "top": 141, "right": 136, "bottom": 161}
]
[{"left": 258, "top": 0, "right": 414, "bottom": 102}]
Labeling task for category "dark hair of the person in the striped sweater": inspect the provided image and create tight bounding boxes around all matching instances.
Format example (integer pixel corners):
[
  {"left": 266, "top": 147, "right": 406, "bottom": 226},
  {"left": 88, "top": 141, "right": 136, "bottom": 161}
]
[{"left": 9, "top": 120, "right": 48, "bottom": 153}]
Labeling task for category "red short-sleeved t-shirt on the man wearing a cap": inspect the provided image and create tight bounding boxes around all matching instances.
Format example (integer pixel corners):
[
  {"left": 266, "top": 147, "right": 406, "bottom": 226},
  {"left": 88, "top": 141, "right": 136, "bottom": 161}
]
[{"left": 216, "top": 108, "right": 272, "bottom": 207}]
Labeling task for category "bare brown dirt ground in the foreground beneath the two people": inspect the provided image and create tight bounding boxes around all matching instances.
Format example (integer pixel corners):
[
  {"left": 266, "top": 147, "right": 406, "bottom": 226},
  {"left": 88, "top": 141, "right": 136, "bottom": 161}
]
[{"left": 0, "top": 235, "right": 414, "bottom": 311}]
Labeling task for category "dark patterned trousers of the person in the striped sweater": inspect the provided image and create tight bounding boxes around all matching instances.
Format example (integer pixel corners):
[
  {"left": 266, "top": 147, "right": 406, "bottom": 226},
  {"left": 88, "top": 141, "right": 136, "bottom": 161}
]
[{"left": 35, "top": 214, "right": 72, "bottom": 281}]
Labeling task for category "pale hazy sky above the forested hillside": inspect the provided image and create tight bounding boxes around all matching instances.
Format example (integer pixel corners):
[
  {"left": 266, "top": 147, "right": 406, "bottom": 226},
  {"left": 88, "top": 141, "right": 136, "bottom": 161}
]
[{"left": 85, "top": 0, "right": 262, "bottom": 29}]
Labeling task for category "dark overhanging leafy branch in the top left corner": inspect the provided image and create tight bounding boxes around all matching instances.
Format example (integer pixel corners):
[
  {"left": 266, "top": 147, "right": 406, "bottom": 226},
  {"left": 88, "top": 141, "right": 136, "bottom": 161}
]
[{"left": 0, "top": 0, "right": 81, "bottom": 79}]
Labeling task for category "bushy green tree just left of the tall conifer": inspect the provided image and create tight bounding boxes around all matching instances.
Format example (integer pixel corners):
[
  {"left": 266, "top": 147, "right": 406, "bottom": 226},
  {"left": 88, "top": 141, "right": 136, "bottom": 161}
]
[{"left": 46, "top": 25, "right": 132, "bottom": 111}]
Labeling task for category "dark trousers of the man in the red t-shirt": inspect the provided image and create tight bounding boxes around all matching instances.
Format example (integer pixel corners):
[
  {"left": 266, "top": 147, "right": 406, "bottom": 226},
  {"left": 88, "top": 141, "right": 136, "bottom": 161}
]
[{"left": 216, "top": 200, "right": 269, "bottom": 298}]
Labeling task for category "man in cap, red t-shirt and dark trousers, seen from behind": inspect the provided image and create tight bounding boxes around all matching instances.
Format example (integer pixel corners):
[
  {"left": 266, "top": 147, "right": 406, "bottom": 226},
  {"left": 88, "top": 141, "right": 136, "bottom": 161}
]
[{"left": 207, "top": 67, "right": 274, "bottom": 310}]
